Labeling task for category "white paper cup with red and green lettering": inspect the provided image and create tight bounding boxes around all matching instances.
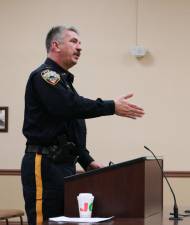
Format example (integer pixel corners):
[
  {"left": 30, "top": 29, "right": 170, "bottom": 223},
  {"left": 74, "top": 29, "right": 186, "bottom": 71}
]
[{"left": 77, "top": 193, "right": 94, "bottom": 218}]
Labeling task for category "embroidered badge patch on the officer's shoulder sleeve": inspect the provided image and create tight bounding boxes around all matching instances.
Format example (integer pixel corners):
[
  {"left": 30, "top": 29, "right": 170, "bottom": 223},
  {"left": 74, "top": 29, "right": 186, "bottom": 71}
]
[{"left": 41, "top": 69, "right": 61, "bottom": 85}]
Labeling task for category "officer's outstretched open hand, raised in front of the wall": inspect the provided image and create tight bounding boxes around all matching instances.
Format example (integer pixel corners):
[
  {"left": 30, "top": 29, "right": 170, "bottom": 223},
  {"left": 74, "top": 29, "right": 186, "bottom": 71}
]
[{"left": 114, "top": 94, "right": 144, "bottom": 119}]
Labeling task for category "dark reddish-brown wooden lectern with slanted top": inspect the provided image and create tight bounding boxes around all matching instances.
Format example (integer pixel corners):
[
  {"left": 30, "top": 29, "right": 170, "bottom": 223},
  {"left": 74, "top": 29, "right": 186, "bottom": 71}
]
[{"left": 64, "top": 157, "right": 163, "bottom": 218}]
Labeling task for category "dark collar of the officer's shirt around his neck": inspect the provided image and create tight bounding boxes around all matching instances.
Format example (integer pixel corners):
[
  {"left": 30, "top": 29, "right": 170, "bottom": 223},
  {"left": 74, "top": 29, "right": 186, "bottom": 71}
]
[{"left": 44, "top": 58, "right": 74, "bottom": 83}]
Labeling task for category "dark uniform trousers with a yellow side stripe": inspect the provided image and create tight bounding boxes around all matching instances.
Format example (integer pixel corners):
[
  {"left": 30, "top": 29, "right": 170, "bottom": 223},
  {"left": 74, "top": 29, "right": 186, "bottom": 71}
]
[{"left": 21, "top": 153, "right": 76, "bottom": 225}]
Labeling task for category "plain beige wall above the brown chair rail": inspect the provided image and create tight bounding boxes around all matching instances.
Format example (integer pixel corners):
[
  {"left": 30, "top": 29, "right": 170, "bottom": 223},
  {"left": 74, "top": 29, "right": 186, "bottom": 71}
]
[{"left": 0, "top": 0, "right": 190, "bottom": 170}]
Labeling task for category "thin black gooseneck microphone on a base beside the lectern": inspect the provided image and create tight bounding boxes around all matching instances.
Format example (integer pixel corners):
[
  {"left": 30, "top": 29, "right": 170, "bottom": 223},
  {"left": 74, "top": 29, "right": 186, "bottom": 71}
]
[{"left": 144, "top": 146, "right": 183, "bottom": 220}]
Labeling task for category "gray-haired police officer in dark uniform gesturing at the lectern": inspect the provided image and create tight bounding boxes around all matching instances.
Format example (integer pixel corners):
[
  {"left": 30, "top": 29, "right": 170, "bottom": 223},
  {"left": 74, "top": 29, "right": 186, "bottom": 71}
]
[{"left": 21, "top": 26, "right": 144, "bottom": 225}]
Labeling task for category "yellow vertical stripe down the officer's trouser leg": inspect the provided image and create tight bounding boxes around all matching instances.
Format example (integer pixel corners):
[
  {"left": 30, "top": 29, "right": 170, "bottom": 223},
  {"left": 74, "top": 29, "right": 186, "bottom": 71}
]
[{"left": 35, "top": 154, "right": 43, "bottom": 224}]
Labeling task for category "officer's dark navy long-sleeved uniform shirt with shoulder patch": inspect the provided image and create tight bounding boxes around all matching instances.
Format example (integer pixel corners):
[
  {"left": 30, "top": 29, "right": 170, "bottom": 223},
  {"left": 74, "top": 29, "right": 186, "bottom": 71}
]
[{"left": 23, "top": 58, "right": 115, "bottom": 168}]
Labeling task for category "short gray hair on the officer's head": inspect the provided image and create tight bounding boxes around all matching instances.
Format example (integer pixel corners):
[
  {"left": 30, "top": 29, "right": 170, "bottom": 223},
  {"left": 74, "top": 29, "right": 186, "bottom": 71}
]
[{"left": 46, "top": 26, "right": 79, "bottom": 53}]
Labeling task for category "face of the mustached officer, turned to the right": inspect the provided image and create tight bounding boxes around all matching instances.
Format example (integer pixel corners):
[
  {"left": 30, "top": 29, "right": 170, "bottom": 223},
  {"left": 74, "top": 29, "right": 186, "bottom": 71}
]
[{"left": 59, "top": 30, "right": 82, "bottom": 69}]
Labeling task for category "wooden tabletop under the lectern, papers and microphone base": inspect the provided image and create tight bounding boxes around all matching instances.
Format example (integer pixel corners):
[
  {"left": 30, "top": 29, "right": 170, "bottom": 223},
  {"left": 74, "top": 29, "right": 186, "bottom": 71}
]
[{"left": 43, "top": 210, "right": 190, "bottom": 225}]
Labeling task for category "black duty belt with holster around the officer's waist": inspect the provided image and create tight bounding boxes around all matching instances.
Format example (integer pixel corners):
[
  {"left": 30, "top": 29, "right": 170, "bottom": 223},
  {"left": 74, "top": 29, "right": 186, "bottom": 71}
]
[{"left": 25, "top": 145, "right": 79, "bottom": 164}]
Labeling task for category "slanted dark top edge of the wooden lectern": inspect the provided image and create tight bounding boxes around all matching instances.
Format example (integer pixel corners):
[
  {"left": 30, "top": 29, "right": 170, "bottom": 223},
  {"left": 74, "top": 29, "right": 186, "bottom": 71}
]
[{"left": 64, "top": 157, "right": 147, "bottom": 181}]
